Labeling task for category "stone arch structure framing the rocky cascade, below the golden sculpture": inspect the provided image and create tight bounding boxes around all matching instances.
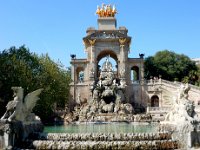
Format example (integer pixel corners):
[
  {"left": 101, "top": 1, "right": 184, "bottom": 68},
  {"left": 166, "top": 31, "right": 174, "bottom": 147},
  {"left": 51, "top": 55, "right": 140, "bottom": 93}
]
[{"left": 70, "top": 14, "right": 146, "bottom": 108}]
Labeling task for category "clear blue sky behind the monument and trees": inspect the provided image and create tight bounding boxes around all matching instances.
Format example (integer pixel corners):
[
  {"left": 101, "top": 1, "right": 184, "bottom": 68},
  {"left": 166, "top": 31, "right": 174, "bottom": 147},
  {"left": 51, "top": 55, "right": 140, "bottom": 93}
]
[{"left": 0, "top": 0, "right": 200, "bottom": 67}]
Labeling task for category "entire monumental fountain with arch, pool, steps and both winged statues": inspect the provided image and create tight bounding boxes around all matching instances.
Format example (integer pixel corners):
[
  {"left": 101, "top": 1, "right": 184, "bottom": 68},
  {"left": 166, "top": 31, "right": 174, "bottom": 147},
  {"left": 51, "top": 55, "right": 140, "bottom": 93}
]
[{"left": 0, "top": 4, "right": 200, "bottom": 150}]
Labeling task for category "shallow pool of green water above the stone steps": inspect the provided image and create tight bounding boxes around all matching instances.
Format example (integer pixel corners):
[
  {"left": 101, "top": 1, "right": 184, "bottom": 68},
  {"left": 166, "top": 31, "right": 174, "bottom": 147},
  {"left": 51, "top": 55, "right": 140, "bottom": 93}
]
[{"left": 44, "top": 122, "right": 158, "bottom": 133}]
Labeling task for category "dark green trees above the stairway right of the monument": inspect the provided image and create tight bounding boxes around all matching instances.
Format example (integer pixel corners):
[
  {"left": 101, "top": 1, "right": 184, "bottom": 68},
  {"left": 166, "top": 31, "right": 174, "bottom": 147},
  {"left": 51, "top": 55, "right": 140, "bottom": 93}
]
[{"left": 145, "top": 50, "right": 198, "bottom": 84}]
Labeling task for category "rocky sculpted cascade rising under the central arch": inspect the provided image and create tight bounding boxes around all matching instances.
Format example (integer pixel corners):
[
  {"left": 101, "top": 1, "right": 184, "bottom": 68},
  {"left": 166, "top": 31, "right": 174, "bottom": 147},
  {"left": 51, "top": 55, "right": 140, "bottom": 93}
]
[{"left": 69, "top": 57, "right": 134, "bottom": 122}]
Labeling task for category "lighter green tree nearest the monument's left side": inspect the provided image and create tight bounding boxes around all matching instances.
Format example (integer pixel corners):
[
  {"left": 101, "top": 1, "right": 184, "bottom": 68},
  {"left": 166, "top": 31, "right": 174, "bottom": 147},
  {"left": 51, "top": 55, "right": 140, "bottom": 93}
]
[{"left": 34, "top": 54, "right": 71, "bottom": 122}]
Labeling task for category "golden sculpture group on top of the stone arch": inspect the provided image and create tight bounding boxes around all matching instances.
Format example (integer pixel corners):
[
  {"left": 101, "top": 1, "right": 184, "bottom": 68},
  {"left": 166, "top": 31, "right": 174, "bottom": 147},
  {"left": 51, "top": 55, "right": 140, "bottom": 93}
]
[{"left": 96, "top": 4, "right": 117, "bottom": 17}]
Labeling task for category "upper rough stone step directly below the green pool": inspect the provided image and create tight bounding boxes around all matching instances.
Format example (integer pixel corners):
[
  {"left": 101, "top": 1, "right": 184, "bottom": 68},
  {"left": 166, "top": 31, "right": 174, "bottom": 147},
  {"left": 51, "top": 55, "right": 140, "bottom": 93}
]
[{"left": 36, "top": 132, "right": 171, "bottom": 141}]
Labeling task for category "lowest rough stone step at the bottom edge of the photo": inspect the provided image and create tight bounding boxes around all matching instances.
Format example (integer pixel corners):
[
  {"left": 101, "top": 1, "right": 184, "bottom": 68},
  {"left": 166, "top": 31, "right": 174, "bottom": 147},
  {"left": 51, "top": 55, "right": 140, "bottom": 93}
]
[{"left": 33, "top": 140, "right": 178, "bottom": 150}]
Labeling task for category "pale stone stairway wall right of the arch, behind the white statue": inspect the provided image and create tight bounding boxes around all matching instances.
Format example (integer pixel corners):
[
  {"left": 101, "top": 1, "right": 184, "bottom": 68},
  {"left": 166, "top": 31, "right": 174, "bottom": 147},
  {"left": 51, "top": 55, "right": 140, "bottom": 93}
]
[{"left": 130, "top": 78, "right": 200, "bottom": 107}]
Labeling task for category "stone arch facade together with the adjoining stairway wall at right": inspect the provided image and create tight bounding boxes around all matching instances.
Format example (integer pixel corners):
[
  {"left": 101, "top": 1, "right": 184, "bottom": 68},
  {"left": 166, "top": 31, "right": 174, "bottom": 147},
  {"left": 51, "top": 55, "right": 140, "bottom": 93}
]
[{"left": 70, "top": 10, "right": 200, "bottom": 113}]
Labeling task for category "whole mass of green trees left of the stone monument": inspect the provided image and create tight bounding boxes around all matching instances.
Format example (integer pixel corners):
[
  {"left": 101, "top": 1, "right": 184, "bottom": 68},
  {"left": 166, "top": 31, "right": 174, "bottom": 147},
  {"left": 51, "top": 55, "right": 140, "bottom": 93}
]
[{"left": 0, "top": 46, "right": 70, "bottom": 121}]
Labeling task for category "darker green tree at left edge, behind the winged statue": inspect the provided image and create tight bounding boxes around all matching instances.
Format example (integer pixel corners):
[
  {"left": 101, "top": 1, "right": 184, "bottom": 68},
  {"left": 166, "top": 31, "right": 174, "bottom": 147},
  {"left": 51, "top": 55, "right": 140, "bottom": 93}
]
[{"left": 0, "top": 46, "right": 41, "bottom": 115}]
